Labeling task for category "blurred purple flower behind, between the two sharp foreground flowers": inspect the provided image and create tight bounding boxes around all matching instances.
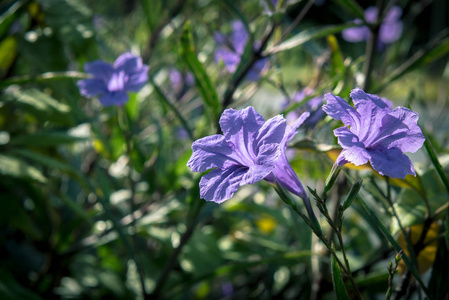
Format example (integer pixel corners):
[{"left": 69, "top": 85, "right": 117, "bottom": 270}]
[{"left": 284, "top": 88, "right": 326, "bottom": 128}]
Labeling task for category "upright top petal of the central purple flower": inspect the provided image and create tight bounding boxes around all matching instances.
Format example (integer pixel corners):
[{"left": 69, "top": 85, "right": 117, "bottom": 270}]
[{"left": 220, "top": 106, "right": 265, "bottom": 166}]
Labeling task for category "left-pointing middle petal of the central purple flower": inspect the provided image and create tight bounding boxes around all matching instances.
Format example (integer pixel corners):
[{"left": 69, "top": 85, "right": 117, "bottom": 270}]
[{"left": 187, "top": 134, "right": 239, "bottom": 172}]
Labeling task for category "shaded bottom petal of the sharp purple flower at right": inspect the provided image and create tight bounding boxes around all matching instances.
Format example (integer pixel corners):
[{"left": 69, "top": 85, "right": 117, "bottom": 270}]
[{"left": 369, "top": 148, "right": 416, "bottom": 178}]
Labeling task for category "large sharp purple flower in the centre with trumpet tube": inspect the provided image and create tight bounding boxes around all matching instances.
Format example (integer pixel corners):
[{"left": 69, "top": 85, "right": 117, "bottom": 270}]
[{"left": 187, "top": 106, "right": 309, "bottom": 203}]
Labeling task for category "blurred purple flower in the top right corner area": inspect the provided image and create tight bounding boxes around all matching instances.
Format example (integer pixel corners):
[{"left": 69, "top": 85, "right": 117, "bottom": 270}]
[{"left": 342, "top": 6, "right": 403, "bottom": 48}]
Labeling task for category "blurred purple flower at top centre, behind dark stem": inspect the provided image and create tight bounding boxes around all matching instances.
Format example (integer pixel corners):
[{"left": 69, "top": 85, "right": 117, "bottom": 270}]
[{"left": 214, "top": 21, "right": 268, "bottom": 81}]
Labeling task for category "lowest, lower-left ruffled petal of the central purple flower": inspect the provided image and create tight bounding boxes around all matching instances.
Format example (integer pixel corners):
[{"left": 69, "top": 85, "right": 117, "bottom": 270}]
[{"left": 200, "top": 166, "right": 248, "bottom": 203}]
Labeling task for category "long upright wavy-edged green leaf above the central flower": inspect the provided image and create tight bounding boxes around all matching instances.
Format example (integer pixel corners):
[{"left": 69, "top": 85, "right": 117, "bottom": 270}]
[{"left": 180, "top": 22, "right": 220, "bottom": 122}]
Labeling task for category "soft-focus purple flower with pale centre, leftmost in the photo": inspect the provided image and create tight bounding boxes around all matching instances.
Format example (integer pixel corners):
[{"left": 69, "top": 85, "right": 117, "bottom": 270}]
[{"left": 78, "top": 52, "right": 149, "bottom": 106}]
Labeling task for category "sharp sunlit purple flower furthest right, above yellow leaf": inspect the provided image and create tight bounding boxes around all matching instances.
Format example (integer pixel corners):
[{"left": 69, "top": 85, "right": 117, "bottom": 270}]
[{"left": 323, "top": 88, "right": 425, "bottom": 178}]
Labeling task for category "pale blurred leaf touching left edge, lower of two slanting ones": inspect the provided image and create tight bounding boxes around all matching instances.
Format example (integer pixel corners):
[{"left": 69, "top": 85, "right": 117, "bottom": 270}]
[{"left": 0, "top": 154, "right": 47, "bottom": 183}]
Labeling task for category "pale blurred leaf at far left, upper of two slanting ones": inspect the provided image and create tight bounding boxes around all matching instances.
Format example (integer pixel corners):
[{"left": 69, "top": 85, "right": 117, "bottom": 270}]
[{"left": 6, "top": 87, "right": 72, "bottom": 124}]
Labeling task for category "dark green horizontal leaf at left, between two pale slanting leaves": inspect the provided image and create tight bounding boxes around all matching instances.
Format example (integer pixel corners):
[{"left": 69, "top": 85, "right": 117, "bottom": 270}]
[{"left": 10, "top": 131, "right": 86, "bottom": 147}]
